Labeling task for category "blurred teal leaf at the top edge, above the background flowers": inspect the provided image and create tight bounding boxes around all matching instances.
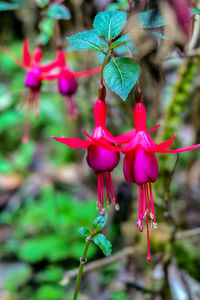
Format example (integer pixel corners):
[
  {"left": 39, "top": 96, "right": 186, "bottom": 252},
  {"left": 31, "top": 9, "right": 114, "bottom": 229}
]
[{"left": 47, "top": 4, "right": 71, "bottom": 20}]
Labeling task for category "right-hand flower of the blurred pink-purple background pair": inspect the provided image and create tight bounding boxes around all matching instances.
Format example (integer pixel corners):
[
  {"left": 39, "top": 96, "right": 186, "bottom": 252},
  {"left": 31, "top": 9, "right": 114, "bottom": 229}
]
[{"left": 46, "top": 49, "right": 101, "bottom": 118}]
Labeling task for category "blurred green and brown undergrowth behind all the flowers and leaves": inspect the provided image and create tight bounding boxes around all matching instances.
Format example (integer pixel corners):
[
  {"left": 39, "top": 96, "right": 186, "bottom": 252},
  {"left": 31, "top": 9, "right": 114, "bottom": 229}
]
[{"left": 0, "top": 0, "right": 200, "bottom": 300}]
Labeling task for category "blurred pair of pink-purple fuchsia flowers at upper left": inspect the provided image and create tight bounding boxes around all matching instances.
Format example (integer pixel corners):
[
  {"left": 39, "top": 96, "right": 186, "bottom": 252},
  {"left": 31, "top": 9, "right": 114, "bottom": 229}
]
[{"left": 3, "top": 39, "right": 101, "bottom": 142}]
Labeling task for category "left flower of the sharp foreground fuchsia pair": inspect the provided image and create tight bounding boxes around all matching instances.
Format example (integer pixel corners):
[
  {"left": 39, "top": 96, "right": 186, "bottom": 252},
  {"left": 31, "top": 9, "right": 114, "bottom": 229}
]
[{"left": 50, "top": 84, "right": 127, "bottom": 210}]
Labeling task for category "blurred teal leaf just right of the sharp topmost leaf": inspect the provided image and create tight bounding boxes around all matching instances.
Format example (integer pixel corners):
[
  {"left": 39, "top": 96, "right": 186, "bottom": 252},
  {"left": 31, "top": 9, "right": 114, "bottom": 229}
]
[{"left": 136, "top": 9, "right": 166, "bottom": 28}]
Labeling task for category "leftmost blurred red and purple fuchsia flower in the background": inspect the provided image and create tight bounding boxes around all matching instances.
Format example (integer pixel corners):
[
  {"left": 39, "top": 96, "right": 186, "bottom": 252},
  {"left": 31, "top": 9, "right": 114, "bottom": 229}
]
[{"left": 3, "top": 39, "right": 57, "bottom": 143}]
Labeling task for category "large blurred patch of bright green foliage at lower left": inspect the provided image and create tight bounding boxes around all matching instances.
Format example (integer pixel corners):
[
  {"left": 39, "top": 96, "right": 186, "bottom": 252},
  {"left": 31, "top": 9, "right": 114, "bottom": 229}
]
[{"left": 1, "top": 188, "right": 95, "bottom": 263}]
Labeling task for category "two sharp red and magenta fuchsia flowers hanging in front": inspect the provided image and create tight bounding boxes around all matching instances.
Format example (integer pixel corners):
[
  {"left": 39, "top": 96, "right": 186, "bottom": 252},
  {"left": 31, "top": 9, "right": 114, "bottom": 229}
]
[{"left": 53, "top": 85, "right": 200, "bottom": 260}]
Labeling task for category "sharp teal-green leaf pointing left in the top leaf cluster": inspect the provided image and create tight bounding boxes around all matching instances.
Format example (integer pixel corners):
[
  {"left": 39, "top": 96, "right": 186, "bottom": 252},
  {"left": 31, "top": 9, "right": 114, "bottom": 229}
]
[{"left": 67, "top": 29, "right": 105, "bottom": 51}]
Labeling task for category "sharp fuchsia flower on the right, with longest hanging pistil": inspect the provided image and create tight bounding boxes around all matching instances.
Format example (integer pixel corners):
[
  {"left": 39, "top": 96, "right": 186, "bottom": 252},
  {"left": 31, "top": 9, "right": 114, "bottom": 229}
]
[{"left": 115, "top": 98, "right": 200, "bottom": 260}]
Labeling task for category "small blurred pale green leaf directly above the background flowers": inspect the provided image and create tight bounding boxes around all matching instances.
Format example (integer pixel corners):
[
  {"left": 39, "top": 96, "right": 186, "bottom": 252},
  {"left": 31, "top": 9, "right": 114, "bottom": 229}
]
[{"left": 38, "top": 18, "right": 54, "bottom": 45}]
